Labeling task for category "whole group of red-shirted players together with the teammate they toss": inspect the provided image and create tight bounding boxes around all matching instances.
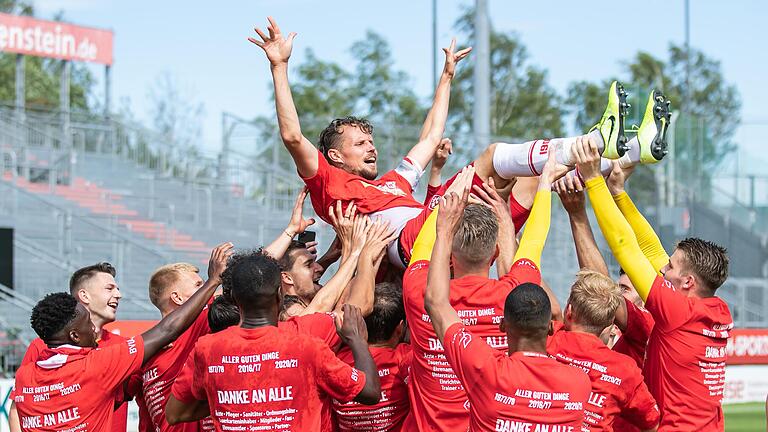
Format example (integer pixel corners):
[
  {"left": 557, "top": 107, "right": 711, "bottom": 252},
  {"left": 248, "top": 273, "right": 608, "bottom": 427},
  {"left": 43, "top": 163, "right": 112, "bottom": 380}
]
[{"left": 11, "top": 18, "right": 733, "bottom": 432}]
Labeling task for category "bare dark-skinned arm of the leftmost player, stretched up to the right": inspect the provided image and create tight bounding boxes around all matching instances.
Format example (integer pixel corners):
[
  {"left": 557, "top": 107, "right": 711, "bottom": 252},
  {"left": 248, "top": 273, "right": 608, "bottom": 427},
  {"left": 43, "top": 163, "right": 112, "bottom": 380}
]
[{"left": 141, "top": 242, "right": 234, "bottom": 363}]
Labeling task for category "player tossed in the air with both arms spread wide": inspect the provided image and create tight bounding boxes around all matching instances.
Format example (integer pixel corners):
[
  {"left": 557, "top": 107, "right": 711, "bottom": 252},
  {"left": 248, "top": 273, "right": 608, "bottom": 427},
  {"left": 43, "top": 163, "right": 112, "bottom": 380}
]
[{"left": 249, "top": 18, "right": 627, "bottom": 268}]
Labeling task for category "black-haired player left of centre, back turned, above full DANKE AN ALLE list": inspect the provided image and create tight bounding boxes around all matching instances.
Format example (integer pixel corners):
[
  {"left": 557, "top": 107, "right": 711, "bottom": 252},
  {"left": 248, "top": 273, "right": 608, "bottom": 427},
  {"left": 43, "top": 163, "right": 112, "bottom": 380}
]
[{"left": 166, "top": 251, "right": 381, "bottom": 431}]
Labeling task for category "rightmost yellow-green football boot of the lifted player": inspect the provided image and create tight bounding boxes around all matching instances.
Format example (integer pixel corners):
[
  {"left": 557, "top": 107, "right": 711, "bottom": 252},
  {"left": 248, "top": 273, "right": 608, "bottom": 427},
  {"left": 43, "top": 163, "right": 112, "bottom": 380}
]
[{"left": 637, "top": 90, "right": 671, "bottom": 164}]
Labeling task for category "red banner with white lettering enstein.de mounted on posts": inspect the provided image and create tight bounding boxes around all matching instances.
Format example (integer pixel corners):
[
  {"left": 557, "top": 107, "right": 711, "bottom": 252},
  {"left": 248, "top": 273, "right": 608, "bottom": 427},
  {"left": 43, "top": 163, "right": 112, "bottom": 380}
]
[{"left": 0, "top": 13, "right": 113, "bottom": 65}]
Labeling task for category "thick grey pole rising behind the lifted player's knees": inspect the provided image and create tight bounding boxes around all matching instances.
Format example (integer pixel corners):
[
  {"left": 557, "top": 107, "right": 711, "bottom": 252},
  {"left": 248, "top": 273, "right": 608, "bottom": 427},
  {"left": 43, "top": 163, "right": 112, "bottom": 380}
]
[{"left": 472, "top": 0, "right": 491, "bottom": 148}]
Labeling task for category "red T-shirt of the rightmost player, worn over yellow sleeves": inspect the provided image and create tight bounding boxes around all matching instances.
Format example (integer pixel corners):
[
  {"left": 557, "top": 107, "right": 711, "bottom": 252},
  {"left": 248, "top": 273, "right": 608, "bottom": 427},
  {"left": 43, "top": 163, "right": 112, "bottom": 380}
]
[{"left": 643, "top": 276, "right": 733, "bottom": 432}]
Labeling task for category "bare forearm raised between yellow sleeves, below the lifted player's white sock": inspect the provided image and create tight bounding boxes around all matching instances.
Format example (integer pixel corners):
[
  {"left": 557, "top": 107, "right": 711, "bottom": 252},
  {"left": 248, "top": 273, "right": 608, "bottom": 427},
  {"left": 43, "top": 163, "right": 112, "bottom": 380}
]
[{"left": 554, "top": 175, "right": 610, "bottom": 277}]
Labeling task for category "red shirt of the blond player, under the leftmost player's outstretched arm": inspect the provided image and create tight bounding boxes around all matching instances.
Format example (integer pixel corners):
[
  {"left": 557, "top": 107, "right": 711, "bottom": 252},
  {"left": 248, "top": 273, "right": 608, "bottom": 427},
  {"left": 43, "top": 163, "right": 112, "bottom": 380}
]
[{"left": 137, "top": 309, "right": 211, "bottom": 432}]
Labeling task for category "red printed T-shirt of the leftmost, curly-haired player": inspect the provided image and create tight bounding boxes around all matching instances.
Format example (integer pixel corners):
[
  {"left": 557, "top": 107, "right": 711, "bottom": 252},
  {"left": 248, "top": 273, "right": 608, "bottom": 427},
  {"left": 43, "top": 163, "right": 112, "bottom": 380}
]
[{"left": 14, "top": 336, "right": 144, "bottom": 432}]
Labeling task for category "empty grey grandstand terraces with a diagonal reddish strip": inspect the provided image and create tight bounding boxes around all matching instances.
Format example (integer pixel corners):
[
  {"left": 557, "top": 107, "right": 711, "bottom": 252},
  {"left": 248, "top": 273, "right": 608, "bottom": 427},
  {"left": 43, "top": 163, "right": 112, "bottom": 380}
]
[{"left": 0, "top": 149, "right": 329, "bottom": 338}]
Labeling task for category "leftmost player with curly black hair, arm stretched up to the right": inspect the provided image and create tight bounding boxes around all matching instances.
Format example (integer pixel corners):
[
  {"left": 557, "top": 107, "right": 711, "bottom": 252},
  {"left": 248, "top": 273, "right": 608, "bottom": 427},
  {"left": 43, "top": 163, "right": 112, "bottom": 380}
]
[{"left": 14, "top": 246, "right": 228, "bottom": 432}]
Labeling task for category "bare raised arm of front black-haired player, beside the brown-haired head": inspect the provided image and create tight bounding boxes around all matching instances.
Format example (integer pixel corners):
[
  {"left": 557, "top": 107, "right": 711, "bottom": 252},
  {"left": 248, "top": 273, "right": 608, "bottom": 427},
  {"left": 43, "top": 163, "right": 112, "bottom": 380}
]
[{"left": 424, "top": 181, "right": 469, "bottom": 342}]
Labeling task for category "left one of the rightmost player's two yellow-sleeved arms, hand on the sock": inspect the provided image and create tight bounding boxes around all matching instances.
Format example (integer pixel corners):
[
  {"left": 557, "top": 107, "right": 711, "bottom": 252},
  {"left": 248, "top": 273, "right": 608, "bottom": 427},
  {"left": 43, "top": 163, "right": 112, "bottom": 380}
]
[{"left": 572, "top": 135, "right": 656, "bottom": 301}]
